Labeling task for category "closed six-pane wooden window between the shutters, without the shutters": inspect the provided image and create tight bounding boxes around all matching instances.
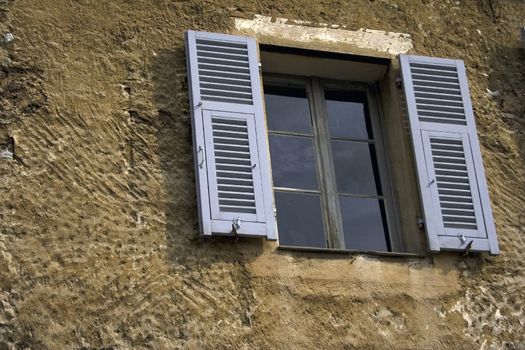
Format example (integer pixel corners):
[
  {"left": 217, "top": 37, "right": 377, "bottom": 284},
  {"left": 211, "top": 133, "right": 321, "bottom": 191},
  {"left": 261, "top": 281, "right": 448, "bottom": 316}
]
[{"left": 264, "top": 76, "right": 395, "bottom": 251}]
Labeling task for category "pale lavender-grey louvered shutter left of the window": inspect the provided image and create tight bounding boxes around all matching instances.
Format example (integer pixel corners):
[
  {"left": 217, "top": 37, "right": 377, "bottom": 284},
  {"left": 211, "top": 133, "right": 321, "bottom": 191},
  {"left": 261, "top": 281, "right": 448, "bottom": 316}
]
[{"left": 186, "top": 31, "right": 277, "bottom": 239}]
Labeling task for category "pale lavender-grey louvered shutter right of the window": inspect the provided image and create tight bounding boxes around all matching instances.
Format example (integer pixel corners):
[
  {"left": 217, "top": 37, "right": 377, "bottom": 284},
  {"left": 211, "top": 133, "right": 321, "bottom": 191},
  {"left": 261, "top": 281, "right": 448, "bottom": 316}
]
[{"left": 400, "top": 55, "right": 499, "bottom": 255}]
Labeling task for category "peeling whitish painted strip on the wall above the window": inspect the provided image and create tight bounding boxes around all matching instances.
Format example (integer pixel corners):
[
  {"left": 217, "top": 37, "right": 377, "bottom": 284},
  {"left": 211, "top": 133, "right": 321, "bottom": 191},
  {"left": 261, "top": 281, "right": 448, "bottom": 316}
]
[{"left": 234, "top": 15, "right": 413, "bottom": 55}]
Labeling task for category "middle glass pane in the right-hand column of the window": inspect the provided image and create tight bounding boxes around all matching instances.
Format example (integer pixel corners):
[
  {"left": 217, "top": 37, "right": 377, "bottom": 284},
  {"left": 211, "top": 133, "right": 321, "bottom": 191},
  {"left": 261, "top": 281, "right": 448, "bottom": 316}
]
[{"left": 332, "top": 141, "right": 381, "bottom": 195}]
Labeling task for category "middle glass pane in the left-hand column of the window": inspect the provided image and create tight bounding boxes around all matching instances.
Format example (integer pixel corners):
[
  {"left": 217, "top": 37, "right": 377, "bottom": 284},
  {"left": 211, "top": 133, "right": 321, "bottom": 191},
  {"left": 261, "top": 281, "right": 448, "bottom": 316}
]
[{"left": 269, "top": 135, "right": 318, "bottom": 190}]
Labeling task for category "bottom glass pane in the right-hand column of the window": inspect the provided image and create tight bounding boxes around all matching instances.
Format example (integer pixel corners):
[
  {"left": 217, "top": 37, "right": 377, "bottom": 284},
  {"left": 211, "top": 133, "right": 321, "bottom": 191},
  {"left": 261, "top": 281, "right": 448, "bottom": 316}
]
[{"left": 339, "top": 196, "right": 388, "bottom": 251}]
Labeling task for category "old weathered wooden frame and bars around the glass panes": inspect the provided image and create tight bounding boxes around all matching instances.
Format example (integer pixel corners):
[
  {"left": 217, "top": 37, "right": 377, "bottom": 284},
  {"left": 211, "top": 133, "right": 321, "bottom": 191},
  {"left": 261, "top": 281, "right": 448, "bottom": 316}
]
[{"left": 263, "top": 73, "right": 403, "bottom": 252}]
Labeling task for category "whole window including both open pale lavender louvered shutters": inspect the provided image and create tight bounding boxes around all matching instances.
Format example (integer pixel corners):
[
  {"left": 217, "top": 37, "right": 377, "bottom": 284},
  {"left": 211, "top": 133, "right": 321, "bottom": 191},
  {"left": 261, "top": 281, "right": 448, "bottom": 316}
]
[{"left": 186, "top": 31, "right": 499, "bottom": 254}]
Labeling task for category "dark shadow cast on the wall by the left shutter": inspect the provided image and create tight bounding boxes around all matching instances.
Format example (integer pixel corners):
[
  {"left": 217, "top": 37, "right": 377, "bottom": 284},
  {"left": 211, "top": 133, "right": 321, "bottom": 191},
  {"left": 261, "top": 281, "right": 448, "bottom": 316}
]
[{"left": 151, "top": 48, "right": 263, "bottom": 266}]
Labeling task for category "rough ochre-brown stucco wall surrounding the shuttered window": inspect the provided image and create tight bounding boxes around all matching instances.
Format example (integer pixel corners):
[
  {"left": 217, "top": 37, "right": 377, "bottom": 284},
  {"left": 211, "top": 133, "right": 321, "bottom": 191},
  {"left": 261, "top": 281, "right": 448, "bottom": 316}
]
[{"left": 0, "top": 0, "right": 525, "bottom": 349}]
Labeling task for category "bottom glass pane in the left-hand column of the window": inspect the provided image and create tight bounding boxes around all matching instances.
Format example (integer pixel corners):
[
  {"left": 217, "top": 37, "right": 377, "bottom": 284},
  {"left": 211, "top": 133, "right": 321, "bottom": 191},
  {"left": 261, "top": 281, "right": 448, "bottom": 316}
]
[{"left": 275, "top": 191, "right": 326, "bottom": 248}]
